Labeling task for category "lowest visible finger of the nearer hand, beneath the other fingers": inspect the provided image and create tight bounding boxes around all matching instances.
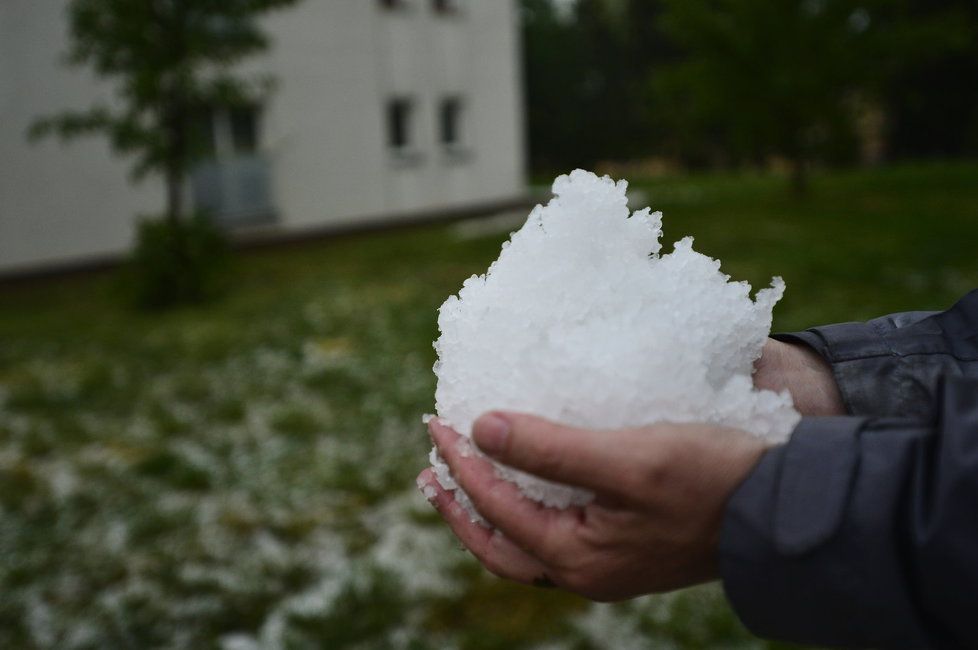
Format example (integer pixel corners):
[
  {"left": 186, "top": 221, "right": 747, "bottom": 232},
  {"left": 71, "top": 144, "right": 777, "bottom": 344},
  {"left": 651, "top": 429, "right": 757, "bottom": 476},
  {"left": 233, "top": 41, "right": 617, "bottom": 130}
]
[{"left": 418, "top": 469, "right": 547, "bottom": 584}]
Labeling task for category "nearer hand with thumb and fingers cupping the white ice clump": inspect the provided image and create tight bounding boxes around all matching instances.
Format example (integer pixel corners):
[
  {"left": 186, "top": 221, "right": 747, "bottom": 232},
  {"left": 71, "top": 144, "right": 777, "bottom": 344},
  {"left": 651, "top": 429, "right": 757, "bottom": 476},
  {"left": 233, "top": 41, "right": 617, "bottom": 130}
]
[{"left": 418, "top": 413, "right": 765, "bottom": 601}]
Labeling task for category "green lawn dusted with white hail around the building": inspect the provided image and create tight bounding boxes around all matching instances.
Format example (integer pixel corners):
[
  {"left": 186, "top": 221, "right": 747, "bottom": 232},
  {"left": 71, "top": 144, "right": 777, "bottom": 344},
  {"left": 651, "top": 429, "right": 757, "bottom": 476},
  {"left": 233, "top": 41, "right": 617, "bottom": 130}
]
[{"left": 0, "top": 164, "right": 978, "bottom": 650}]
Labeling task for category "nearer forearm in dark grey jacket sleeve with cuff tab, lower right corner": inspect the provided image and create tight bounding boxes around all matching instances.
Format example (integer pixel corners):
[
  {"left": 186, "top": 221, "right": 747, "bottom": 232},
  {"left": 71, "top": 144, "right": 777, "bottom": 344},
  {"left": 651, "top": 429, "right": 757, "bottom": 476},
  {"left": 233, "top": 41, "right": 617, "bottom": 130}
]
[{"left": 720, "top": 379, "right": 978, "bottom": 648}]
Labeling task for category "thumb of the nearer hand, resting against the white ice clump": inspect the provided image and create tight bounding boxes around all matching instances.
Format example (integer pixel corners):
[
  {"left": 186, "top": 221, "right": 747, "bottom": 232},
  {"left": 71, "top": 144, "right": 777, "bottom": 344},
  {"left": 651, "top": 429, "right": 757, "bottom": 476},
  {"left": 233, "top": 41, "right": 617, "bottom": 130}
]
[{"left": 472, "top": 411, "right": 650, "bottom": 498}]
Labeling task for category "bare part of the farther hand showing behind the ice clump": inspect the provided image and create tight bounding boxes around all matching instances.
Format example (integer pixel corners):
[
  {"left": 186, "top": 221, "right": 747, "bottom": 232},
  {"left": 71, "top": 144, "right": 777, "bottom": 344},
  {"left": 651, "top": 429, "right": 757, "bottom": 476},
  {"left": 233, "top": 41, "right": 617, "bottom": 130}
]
[{"left": 754, "top": 339, "right": 846, "bottom": 415}]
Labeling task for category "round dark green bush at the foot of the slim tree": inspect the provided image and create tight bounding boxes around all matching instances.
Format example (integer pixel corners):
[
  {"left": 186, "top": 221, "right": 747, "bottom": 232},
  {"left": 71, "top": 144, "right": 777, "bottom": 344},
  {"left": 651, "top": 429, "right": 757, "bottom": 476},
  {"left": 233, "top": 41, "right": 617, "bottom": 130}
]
[{"left": 127, "top": 214, "right": 228, "bottom": 309}]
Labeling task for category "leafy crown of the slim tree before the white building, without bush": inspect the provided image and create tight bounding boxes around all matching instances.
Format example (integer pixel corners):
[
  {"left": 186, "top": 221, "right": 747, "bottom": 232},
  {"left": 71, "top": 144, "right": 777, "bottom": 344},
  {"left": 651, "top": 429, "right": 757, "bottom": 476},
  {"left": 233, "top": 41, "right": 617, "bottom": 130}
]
[{"left": 30, "top": 0, "right": 296, "bottom": 226}]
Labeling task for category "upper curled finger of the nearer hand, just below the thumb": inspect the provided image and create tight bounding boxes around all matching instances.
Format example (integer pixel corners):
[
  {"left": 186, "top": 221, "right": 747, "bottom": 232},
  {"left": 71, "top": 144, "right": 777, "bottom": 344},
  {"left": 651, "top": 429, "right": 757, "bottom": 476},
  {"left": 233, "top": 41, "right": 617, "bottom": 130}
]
[{"left": 428, "top": 420, "right": 578, "bottom": 561}]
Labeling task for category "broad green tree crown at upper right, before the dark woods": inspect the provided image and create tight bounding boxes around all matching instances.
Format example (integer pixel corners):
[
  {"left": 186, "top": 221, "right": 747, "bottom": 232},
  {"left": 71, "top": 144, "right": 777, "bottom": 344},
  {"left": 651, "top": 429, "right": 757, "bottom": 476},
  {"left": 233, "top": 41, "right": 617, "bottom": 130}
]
[{"left": 653, "top": 0, "right": 965, "bottom": 191}]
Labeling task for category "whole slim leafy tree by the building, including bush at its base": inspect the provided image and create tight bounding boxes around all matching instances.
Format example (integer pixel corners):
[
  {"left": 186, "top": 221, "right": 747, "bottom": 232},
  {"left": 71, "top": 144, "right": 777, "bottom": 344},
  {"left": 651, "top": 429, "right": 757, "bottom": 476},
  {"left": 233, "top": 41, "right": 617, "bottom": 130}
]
[{"left": 29, "top": 0, "right": 297, "bottom": 307}]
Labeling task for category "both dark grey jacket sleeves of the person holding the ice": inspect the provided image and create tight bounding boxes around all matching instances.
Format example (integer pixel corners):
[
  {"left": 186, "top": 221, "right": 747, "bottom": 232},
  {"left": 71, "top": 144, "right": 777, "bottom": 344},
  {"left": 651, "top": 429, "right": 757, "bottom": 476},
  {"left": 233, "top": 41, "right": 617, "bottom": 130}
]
[{"left": 720, "top": 291, "right": 978, "bottom": 648}]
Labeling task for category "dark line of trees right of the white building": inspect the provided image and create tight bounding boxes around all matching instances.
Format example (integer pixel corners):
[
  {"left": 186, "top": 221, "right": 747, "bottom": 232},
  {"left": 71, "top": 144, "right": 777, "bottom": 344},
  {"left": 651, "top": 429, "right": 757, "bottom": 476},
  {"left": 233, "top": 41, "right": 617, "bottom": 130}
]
[{"left": 522, "top": 0, "right": 978, "bottom": 180}]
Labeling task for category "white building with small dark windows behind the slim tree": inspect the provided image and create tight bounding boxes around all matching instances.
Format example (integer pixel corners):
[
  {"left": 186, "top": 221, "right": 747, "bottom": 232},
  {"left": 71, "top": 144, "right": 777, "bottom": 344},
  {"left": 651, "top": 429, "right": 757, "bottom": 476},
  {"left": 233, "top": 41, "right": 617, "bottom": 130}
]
[{"left": 0, "top": 0, "right": 524, "bottom": 273}]
